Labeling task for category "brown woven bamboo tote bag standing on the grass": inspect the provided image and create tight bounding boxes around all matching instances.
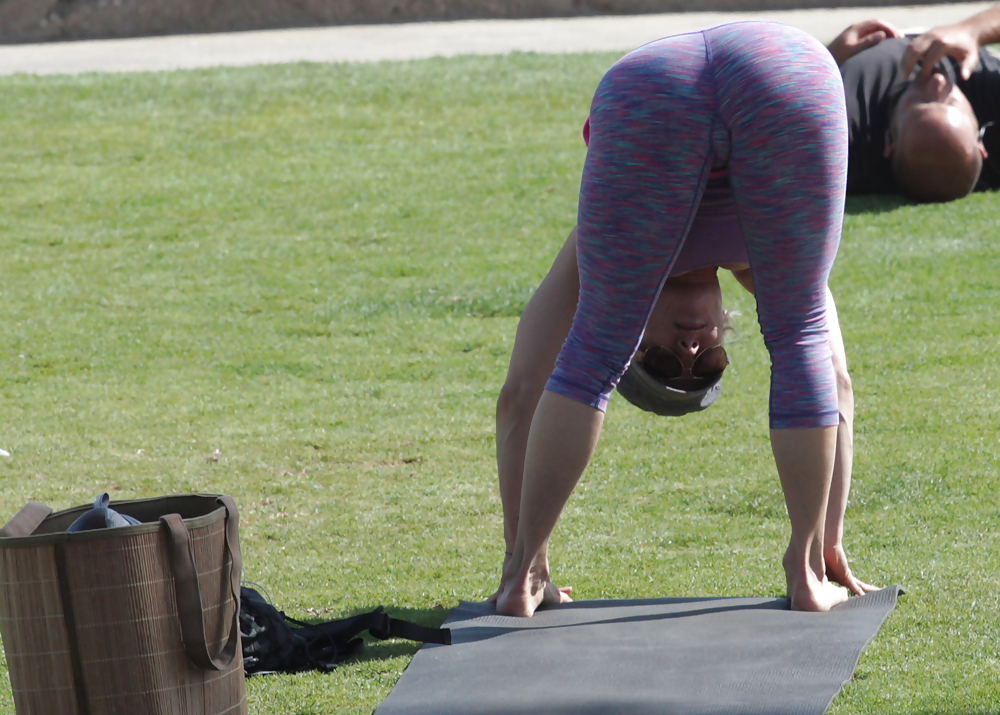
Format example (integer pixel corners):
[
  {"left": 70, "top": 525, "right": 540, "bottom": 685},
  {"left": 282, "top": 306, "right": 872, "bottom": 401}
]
[{"left": 0, "top": 495, "right": 247, "bottom": 715}]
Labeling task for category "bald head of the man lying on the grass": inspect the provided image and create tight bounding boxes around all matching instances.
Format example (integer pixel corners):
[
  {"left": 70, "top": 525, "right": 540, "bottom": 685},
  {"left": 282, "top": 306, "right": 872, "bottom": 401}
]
[{"left": 890, "top": 102, "right": 983, "bottom": 201}]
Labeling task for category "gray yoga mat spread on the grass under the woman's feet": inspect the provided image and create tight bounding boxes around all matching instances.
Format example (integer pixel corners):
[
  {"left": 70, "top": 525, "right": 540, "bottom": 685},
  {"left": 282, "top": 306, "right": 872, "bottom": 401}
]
[{"left": 375, "top": 586, "right": 901, "bottom": 715}]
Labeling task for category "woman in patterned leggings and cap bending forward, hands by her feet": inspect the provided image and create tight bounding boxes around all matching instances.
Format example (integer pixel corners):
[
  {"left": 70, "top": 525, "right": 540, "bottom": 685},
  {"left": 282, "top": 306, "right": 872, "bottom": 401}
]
[{"left": 493, "top": 22, "right": 873, "bottom": 616}]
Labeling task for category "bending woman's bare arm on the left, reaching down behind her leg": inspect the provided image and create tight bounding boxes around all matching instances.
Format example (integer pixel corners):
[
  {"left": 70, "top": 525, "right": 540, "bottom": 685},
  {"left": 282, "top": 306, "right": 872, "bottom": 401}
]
[{"left": 493, "top": 228, "right": 580, "bottom": 600}]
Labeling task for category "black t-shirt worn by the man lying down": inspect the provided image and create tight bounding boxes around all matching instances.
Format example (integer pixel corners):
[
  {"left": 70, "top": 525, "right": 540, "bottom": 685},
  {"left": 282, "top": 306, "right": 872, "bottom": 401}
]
[{"left": 840, "top": 39, "right": 1000, "bottom": 194}]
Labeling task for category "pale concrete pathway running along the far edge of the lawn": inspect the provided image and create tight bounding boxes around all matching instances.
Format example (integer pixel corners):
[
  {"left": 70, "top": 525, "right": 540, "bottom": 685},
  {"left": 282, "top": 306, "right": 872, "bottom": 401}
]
[{"left": 0, "top": 2, "right": 993, "bottom": 75}]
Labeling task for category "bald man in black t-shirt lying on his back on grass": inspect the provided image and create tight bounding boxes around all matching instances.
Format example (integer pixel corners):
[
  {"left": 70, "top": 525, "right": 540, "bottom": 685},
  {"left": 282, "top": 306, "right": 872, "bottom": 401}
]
[{"left": 829, "top": 5, "right": 1000, "bottom": 201}]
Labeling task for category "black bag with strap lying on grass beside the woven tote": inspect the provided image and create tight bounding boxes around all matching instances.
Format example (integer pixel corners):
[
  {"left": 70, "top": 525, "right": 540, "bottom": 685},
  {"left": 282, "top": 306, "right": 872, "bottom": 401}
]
[{"left": 240, "top": 586, "right": 451, "bottom": 676}]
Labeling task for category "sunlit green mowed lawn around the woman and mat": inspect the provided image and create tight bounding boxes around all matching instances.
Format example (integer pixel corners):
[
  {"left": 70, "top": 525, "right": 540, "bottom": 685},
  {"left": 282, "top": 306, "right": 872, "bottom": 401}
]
[{"left": 0, "top": 55, "right": 1000, "bottom": 715}]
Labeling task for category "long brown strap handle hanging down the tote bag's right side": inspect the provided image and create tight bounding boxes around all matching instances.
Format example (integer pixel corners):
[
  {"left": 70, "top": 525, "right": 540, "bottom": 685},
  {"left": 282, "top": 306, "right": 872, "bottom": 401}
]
[{"left": 160, "top": 495, "right": 243, "bottom": 670}]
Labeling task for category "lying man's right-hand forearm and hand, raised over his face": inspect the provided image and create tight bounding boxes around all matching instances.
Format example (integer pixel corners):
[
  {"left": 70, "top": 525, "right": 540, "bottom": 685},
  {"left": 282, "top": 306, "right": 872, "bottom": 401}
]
[{"left": 899, "top": 4, "right": 1000, "bottom": 79}]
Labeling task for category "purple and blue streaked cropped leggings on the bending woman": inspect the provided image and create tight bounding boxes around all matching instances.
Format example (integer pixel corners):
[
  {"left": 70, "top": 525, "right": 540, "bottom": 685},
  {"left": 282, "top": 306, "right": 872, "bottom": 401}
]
[{"left": 546, "top": 22, "right": 847, "bottom": 428}]
